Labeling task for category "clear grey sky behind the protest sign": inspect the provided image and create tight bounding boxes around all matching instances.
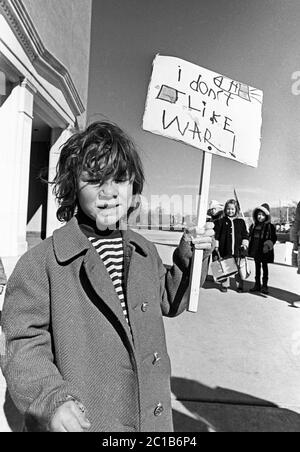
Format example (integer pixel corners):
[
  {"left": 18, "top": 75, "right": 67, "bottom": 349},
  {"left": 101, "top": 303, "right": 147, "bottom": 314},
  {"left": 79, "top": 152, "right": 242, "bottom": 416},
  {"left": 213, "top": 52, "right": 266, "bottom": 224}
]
[{"left": 87, "top": 0, "right": 300, "bottom": 215}]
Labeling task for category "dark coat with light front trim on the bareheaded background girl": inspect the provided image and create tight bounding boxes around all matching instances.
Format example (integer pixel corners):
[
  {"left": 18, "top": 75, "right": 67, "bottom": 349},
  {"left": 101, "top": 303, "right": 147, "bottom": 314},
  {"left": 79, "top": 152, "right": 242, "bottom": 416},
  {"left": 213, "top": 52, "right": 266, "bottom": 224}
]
[{"left": 215, "top": 215, "right": 248, "bottom": 257}]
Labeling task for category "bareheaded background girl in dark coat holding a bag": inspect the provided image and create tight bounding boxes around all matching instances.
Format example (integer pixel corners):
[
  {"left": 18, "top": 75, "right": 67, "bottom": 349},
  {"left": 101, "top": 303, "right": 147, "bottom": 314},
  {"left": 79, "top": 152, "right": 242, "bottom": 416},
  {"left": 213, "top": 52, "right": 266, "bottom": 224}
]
[{"left": 215, "top": 199, "right": 249, "bottom": 292}]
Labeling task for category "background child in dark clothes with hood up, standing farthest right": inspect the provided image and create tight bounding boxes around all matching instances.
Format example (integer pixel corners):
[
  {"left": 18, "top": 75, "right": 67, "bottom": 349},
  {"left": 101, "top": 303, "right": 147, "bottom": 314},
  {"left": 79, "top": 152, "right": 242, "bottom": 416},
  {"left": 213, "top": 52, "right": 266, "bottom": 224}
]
[{"left": 249, "top": 203, "right": 277, "bottom": 294}]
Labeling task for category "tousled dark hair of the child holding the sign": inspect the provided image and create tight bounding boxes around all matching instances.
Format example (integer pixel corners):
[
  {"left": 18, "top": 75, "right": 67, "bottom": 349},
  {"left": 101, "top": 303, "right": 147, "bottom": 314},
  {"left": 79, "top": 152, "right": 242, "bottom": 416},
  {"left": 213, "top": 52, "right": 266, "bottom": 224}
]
[{"left": 53, "top": 121, "right": 144, "bottom": 221}]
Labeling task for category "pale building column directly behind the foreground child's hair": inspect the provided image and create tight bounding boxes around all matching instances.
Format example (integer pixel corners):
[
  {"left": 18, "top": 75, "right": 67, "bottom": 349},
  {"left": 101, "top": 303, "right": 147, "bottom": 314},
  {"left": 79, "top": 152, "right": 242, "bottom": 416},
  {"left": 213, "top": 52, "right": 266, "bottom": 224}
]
[{"left": 46, "top": 126, "right": 74, "bottom": 237}]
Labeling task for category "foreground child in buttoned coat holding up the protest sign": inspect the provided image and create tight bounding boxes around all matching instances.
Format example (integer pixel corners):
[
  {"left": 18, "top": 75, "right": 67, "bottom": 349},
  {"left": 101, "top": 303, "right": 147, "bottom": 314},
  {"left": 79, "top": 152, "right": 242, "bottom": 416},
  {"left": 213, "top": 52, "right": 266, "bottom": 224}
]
[{"left": 1, "top": 122, "right": 214, "bottom": 432}]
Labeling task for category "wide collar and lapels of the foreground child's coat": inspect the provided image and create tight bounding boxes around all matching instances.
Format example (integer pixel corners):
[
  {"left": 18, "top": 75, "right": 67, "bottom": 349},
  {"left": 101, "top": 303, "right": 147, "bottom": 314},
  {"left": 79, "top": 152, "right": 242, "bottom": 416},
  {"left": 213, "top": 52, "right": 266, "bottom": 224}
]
[{"left": 53, "top": 217, "right": 152, "bottom": 347}]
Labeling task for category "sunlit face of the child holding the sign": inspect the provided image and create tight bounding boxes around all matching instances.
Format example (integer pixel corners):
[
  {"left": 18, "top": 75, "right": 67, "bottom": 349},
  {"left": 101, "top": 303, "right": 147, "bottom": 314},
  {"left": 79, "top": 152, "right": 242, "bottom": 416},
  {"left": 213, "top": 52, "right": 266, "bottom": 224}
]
[{"left": 78, "top": 173, "right": 132, "bottom": 230}]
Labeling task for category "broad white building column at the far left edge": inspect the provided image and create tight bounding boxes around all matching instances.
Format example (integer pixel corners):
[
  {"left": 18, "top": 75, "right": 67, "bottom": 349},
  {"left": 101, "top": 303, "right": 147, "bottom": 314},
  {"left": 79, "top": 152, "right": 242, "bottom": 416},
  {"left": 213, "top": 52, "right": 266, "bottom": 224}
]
[{"left": 0, "top": 79, "right": 36, "bottom": 257}]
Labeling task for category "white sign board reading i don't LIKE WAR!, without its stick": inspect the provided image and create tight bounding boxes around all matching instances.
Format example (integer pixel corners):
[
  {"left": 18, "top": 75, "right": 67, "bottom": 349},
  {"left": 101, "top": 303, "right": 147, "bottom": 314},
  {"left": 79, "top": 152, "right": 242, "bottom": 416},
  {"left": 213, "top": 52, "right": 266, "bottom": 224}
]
[{"left": 143, "top": 55, "right": 263, "bottom": 167}]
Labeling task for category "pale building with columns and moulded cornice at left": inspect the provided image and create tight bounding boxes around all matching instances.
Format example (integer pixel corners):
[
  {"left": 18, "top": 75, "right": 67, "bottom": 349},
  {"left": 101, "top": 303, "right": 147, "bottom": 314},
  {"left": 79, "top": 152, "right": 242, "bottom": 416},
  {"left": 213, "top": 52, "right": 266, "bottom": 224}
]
[{"left": 0, "top": 0, "right": 92, "bottom": 262}]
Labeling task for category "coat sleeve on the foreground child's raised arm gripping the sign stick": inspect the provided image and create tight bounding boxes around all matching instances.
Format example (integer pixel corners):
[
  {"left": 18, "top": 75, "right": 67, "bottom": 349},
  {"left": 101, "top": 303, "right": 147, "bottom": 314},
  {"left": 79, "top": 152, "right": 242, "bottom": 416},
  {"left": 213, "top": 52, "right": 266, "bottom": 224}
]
[{"left": 156, "top": 238, "right": 211, "bottom": 317}]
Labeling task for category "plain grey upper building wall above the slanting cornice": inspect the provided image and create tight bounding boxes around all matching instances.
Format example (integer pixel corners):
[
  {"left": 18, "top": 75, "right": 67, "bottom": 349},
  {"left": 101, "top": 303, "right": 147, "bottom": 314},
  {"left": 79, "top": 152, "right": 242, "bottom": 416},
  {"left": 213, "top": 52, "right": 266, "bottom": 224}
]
[{"left": 23, "top": 0, "right": 92, "bottom": 112}]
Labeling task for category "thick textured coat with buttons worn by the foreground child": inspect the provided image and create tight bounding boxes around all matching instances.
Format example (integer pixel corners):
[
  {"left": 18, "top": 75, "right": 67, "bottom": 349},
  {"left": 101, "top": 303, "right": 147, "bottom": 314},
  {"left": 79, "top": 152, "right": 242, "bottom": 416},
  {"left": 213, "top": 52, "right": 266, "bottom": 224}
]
[{"left": 1, "top": 217, "right": 208, "bottom": 432}]
